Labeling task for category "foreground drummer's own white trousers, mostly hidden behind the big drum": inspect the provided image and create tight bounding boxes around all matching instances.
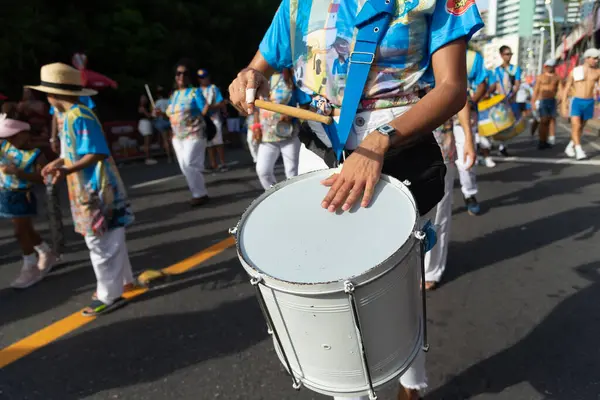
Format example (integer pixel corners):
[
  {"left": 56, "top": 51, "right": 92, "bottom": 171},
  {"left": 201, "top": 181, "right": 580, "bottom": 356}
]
[{"left": 298, "top": 107, "right": 427, "bottom": 400}]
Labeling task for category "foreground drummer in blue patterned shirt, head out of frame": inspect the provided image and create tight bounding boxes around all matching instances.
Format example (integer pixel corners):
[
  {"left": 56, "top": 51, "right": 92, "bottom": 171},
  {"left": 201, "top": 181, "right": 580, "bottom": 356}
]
[{"left": 229, "top": 0, "right": 483, "bottom": 400}]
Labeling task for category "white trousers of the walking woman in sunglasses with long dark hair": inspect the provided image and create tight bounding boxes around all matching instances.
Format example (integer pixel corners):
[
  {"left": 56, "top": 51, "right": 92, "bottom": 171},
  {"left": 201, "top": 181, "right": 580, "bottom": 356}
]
[{"left": 173, "top": 138, "right": 208, "bottom": 199}]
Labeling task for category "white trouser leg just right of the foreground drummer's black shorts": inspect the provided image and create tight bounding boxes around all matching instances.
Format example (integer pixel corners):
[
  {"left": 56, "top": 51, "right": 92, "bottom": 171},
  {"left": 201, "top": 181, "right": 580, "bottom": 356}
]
[{"left": 425, "top": 167, "right": 460, "bottom": 282}]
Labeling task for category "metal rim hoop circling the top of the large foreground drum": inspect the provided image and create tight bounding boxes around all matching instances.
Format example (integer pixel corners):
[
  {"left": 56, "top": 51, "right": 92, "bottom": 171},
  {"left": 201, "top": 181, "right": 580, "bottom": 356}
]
[{"left": 235, "top": 168, "right": 420, "bottom": 294}]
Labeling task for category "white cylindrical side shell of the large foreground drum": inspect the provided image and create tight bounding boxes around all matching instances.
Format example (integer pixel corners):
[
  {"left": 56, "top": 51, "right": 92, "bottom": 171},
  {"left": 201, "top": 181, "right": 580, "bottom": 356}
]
[{"left": 234, "top": 241, "right": 423, "bottom": 396}]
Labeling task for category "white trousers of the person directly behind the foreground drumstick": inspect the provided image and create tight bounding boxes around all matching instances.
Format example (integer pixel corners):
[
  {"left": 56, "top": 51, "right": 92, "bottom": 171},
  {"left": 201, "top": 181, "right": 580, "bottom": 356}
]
[{"left": 256, "top": 137, "right": 300, "bottom": 190}]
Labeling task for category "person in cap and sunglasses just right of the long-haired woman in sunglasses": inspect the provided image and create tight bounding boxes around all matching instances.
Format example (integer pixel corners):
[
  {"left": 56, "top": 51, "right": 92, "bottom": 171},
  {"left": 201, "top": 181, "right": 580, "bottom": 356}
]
[{"left": 198, "top": 69, "right": 227, "bottom": 172}]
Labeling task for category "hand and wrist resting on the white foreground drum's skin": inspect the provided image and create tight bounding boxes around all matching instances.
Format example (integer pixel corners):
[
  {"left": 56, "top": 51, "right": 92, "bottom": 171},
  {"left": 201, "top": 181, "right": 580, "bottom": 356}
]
[{"left": 321, "top": 133, "right": 389, "bottom": 212}]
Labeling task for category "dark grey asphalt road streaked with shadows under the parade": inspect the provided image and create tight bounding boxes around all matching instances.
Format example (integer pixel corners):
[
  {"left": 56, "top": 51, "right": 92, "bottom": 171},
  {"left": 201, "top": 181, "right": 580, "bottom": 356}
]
[{"left": 0, "top": 123, "right": 600, "bottom": 400}]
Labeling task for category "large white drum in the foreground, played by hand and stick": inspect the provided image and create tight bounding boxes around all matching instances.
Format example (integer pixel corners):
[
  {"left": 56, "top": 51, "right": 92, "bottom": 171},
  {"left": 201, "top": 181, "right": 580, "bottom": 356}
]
[{"left": 231, "top": 170, "right": 426, "bottom": 399}]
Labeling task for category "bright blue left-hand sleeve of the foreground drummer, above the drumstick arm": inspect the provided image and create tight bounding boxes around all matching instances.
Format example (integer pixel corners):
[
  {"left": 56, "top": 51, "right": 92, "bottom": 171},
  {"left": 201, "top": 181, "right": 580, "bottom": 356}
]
[{"left": 258, "top": 0, "right": 292, "bottom": 71}]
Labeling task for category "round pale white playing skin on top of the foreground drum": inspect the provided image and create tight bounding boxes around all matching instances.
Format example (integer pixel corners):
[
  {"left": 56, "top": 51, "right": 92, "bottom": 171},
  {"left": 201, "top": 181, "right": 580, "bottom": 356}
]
[{"left": 238, "top": 170, "right": 417, "bottom": 284}]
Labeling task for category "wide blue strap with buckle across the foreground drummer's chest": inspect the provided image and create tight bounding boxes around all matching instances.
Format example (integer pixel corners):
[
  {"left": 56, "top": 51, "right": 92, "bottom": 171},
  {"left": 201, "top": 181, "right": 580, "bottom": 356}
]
[{"left": 323, "top": 0, "right": 396, "bottom": 161}]
